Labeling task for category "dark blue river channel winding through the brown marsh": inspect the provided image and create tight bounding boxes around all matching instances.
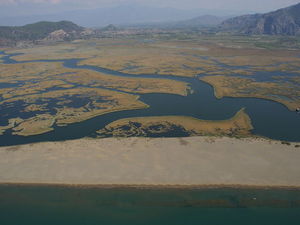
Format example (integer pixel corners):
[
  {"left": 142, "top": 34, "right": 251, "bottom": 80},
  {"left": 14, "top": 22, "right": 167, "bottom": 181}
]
[{"left": 0, "top": 52, "right": 300, "bottom": 146}]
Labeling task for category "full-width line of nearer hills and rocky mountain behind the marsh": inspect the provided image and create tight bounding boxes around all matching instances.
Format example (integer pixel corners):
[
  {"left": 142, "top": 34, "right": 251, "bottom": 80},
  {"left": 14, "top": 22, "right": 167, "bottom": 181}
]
[{"left": 0, "top": 3, "right": 300, "bottom": 46}]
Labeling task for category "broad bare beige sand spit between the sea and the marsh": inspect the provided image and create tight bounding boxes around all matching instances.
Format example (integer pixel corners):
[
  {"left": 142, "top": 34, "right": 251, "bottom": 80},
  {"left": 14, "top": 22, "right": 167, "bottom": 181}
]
[{"left": 0, "top": 137, "right": 300, "bottom": 187}]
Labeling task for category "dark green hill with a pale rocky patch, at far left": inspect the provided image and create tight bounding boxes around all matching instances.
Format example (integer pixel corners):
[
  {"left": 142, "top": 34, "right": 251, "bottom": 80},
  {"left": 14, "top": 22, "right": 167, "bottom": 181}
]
[{"left": 0, "top": 21, "right": 85, "bottom": 45}]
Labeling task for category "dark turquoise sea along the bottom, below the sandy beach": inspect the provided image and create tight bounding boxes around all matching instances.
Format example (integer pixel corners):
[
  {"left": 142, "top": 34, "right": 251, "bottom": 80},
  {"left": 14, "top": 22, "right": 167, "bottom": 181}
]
[{"left": 0, "top": 185, "right": 300, "bottom": 225}]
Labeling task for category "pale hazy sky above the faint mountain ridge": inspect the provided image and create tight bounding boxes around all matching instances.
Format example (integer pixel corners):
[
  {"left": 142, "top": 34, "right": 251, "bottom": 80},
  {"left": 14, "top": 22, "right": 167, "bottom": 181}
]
[{"left": 0, "top": 0, "right": 300, "bottom": 17}]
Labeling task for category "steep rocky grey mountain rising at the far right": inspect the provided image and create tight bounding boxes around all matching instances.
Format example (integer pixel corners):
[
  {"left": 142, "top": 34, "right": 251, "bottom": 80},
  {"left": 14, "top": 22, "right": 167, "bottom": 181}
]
[{"left": 221, "top": 3, "right": 300, "bottom": 35}]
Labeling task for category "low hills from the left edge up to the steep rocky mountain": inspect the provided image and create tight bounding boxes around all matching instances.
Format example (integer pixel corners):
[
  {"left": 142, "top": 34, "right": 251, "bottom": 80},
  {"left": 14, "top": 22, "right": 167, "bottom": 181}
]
[{"left": 0, "top": 15, "right": 230, "bottom": 46}]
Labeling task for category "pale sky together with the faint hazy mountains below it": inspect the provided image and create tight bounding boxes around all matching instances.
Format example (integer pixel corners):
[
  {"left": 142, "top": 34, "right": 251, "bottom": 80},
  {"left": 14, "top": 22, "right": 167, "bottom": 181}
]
[{"left": 0, "top": 0, "right": 300, "bottom": 27}]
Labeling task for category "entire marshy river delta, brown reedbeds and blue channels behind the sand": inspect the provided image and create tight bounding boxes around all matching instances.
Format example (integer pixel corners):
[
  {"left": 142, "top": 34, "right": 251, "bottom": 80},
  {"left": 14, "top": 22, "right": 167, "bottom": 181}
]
[{"left": 0, "top": 35, "right": 300, "bottom": 145}]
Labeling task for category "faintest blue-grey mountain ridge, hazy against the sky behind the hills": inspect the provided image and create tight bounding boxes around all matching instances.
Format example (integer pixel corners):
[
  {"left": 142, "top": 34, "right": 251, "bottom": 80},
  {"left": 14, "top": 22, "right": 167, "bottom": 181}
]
[{"left": 0, "top": 4, "right": 237, "bottom": 27}]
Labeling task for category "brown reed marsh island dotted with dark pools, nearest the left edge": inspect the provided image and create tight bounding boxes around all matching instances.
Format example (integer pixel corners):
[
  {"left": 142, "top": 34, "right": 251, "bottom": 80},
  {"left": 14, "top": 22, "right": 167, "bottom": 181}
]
[{"left": 0, "top": 88, "right": 148, "bottom": 136}]
